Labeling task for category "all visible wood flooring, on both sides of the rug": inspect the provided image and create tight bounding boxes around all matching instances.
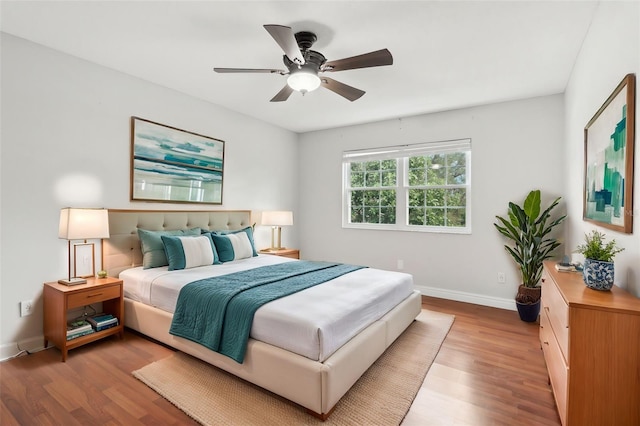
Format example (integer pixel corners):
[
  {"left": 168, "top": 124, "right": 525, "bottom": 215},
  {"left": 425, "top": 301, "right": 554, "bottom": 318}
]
[{"left": 0, "top": 297, "right": 560, "bottom": 426}]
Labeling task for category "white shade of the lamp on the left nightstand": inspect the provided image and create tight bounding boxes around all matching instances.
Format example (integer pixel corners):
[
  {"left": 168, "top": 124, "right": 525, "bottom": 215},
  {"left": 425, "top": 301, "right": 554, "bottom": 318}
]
[{"left": 58, "top": 208, "right": 109, "bottom": 240}]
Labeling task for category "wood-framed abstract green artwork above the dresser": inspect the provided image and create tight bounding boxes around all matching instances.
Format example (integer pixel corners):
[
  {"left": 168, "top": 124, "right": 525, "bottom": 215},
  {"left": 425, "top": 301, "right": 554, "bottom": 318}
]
[{"left": 582, "top": 74, "right": 636, "bottom": 234}]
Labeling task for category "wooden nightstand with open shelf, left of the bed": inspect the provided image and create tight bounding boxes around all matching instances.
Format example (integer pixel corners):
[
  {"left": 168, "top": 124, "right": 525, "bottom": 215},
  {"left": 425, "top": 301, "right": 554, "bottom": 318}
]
[{"left": 43, "top": 278, "right": 124, "bottom": 362}]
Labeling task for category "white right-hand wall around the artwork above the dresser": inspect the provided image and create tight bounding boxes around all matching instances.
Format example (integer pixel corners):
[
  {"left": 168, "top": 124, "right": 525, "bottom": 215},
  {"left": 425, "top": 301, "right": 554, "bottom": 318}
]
[{"left": 565, "top": 2, "right": 640, "bottom": 296}]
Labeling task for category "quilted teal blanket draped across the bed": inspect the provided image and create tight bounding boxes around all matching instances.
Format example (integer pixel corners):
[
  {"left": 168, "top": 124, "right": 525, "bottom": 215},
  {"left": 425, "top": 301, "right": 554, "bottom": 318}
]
[{"left": 169, "top": 261, "right": 363, "bottom": 363}]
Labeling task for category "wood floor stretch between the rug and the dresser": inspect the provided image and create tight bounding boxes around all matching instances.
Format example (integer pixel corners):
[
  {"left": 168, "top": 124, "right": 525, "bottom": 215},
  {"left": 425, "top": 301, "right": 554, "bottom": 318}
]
[{"left": 403, "top": 296, "right": 560, "bottom": 426}]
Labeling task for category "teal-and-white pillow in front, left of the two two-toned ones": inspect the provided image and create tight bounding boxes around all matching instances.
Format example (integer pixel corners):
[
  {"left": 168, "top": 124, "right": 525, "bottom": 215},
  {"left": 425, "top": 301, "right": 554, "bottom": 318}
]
[{"left": 161, "top": 234, "right": 220, "bottom": 271}]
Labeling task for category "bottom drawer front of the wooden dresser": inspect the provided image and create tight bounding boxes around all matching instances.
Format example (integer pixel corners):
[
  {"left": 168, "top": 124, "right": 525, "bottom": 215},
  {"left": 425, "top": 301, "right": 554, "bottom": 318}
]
[{"left": 540, "top": 311, "right": 569, "bottom": 424}]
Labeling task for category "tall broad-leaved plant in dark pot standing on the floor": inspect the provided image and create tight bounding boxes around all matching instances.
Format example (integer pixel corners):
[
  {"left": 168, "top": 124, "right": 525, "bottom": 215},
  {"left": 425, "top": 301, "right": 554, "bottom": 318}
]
[{"left": 493, "top": 189, "right": 566, "bottom": 322}]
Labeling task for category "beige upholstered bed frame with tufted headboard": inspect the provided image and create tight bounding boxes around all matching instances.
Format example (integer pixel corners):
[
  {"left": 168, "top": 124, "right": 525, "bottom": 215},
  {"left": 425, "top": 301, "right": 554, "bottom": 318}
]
[{"left": 102, "top": 209, "right": 422, "bottom": 420}]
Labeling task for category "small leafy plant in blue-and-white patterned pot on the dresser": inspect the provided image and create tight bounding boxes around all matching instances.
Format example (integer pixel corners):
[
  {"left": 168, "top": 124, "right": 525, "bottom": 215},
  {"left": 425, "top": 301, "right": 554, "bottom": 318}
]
[{"left": 576, "top": 229, "right": 624, "bottom": 290}]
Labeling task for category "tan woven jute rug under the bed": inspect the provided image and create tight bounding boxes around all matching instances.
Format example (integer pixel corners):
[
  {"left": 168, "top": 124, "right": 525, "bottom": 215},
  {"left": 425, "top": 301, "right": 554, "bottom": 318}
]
[{"left": 133, "top": 309, "right": 454, "bottom": 425}]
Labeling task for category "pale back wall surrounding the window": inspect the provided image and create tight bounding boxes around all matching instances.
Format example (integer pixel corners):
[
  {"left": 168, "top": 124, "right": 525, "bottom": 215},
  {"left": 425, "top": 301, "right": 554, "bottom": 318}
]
[{"left": 299, "top": 95, "right": 565, "bottom": 309}]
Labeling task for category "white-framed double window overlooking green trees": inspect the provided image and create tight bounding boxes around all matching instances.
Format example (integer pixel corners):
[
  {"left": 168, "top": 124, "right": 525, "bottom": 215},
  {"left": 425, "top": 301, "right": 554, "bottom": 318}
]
[{"left": 342, "top": 139, "right": 471, "bottom": 233}]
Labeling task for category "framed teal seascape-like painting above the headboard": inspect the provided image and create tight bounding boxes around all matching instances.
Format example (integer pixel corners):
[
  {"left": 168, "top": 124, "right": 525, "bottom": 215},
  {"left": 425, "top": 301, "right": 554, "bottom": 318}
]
[{"left": 131, "top": 117, "right": 224, "bottom": 204}]
